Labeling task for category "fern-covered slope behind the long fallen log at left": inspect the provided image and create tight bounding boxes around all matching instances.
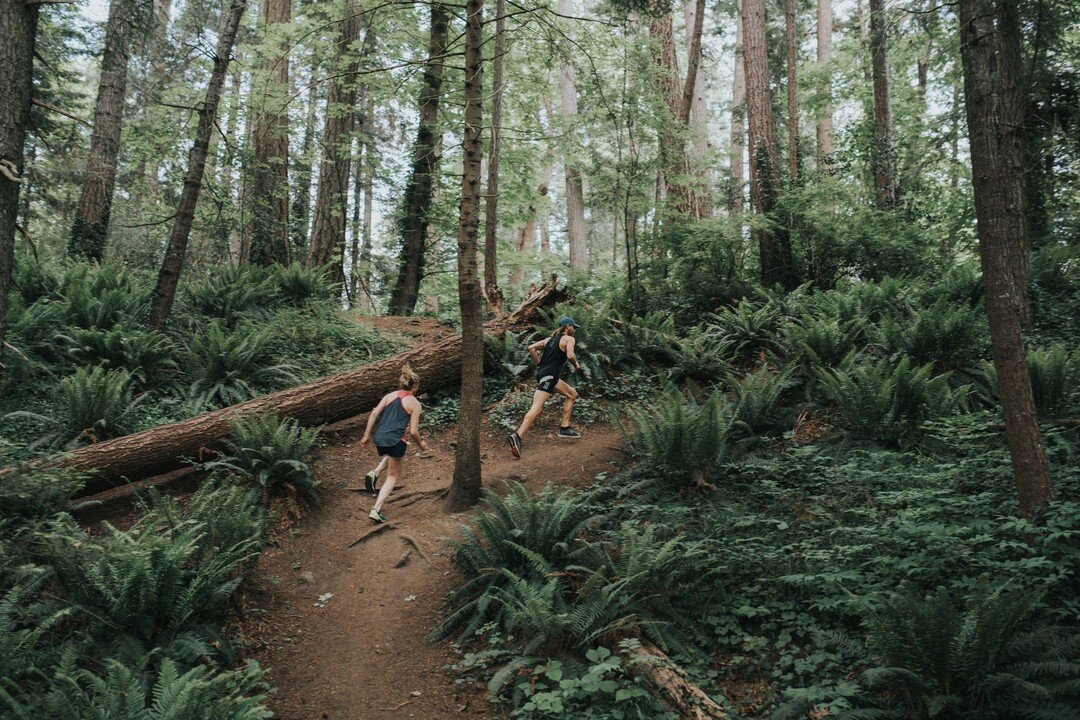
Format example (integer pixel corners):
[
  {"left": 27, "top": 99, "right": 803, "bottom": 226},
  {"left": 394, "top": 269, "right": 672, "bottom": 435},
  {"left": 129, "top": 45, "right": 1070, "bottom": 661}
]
[{"left": 0, "top": 258, "right": 401, "bottom": 460}]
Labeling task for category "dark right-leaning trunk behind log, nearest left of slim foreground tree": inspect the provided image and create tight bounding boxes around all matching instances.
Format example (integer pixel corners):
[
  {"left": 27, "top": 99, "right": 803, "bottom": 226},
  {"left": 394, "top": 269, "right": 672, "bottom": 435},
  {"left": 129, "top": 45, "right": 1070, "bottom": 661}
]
[{"left": 389, "top": 2, "right": 449, "bottom": 315}]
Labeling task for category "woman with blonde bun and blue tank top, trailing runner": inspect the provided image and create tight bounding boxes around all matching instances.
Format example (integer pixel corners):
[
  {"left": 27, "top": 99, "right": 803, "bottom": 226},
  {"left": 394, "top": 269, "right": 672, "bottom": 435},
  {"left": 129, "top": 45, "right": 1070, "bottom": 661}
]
[{"left": 360, "top": 365, "right": 429, "bottom": 522}]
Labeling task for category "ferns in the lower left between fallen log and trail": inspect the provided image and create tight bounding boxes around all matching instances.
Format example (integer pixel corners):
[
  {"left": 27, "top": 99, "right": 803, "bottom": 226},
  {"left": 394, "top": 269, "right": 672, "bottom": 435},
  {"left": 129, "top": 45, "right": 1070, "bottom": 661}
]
[{"left": 0, "top": 416, "right": 318, "bottom": 720}]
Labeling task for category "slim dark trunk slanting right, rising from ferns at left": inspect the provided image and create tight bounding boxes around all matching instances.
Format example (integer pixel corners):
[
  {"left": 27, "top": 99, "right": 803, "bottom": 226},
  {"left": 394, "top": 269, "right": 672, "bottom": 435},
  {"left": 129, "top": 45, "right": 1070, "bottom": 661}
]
[{"left": 148, "top": 0, "right": 247, "bottom": 329}]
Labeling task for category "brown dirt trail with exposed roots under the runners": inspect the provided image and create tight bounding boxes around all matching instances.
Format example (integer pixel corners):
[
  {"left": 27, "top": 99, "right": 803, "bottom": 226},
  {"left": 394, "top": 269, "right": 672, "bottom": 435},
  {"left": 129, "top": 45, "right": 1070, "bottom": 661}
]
[{"left": 243, "top": 414, "right": 624, "bottom": 720}]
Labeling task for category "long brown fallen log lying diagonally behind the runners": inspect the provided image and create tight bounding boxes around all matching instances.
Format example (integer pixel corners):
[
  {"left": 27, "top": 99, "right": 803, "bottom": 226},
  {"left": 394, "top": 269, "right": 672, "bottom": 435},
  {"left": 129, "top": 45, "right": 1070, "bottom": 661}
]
[{"left": 8, "top": 275, "right": 565, "bottom": 495}]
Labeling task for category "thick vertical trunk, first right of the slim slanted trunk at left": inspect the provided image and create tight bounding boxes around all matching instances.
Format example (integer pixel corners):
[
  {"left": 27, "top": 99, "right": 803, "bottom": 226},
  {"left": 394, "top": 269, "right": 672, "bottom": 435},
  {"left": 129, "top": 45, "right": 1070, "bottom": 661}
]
[{"left": 248, "top": 0, "right": 293, "bottom": 264}]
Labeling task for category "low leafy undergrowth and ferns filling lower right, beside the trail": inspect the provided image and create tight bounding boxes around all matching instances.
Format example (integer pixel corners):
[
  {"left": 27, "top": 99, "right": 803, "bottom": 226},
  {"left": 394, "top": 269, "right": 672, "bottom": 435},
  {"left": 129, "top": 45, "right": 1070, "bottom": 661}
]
[{"left": 437, "top": 416, "right": 1080, "bottom": 718}]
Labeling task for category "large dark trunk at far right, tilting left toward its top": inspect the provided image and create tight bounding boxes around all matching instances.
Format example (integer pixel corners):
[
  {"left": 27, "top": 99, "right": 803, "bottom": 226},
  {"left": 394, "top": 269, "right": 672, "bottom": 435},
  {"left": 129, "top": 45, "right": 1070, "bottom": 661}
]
[{"left": 959, "top": 0, "right": 1053, "bottom": 518}]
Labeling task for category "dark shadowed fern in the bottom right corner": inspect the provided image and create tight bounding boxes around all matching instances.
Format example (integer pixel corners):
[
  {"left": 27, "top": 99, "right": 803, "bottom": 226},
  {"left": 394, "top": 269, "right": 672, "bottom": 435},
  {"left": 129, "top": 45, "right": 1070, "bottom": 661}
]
[{"left": 840, "top": 584, "right": 1080, "bottom": 720}]
